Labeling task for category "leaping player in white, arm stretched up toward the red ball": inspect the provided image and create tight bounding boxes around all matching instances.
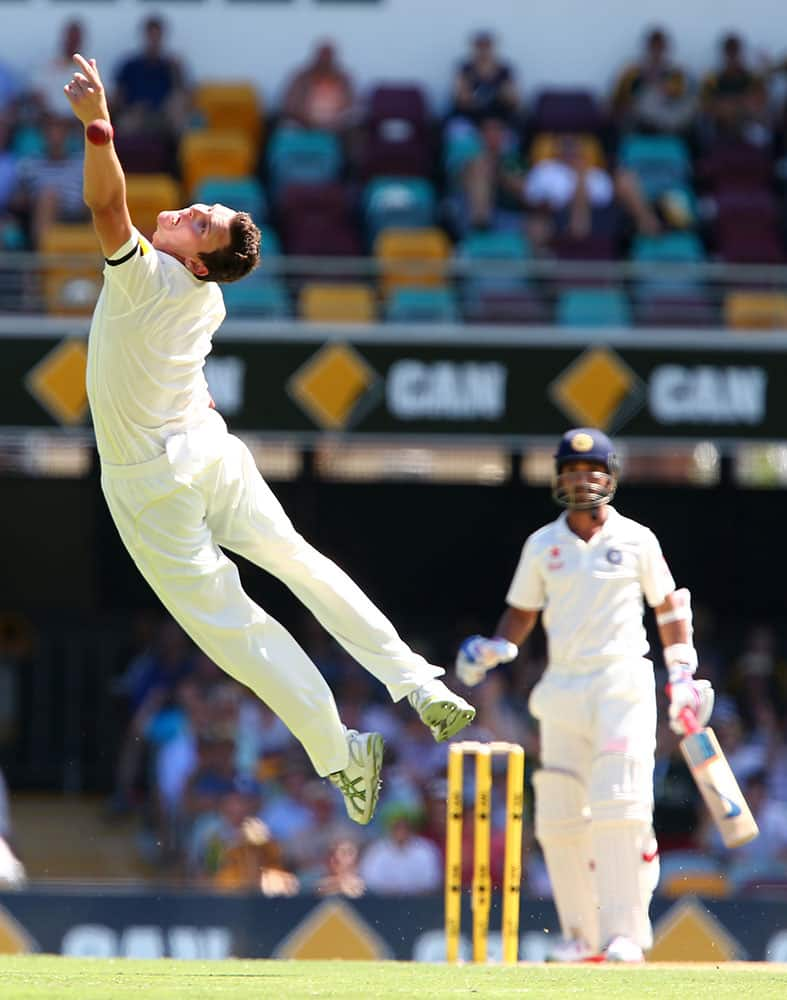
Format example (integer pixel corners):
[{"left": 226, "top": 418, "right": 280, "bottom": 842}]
[{"left": 64, "top": 55, "right": 475, "bottom": 823}]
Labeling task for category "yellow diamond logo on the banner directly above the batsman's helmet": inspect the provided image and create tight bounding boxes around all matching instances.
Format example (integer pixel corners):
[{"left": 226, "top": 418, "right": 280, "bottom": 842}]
[{"left": 549, "top": 347, "right": 645, "bottom": 430}]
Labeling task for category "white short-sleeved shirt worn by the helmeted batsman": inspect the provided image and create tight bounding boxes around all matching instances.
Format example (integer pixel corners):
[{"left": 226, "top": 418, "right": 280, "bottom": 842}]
[{"left": 506, "top": 507, "right": 675, "bottom": 673}]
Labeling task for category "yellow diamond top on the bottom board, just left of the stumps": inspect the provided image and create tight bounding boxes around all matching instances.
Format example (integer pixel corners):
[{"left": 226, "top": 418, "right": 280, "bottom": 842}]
[{"left": 274, "top": 900, "right": 390, "bottom": 961}]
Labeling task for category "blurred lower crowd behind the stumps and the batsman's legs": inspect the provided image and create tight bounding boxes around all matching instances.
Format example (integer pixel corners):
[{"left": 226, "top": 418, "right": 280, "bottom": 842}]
[{"left": 100, "top": 608, "right": 787, "bottom": 898}]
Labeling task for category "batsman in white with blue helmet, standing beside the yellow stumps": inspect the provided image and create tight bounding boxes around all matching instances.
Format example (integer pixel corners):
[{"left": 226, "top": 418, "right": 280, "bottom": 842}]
[{"left": 457, "top": 427, "right": 713, "bottom": 962}]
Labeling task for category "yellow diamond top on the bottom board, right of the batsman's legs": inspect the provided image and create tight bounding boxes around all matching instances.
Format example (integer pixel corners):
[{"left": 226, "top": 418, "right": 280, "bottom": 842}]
[{"left": 648, "top": 899, "right": 742, "bottom": 962}]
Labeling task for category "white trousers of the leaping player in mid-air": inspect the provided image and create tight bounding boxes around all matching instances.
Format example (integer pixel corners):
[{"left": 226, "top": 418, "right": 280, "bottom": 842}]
[{"left": 101, "top": 412, "right": 444, "bottom": 776}]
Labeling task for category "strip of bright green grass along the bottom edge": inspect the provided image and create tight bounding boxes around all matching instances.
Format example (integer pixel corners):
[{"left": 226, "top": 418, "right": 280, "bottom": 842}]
[{"left": 0, "top": 955, "right": 787, "bottom": 1000}]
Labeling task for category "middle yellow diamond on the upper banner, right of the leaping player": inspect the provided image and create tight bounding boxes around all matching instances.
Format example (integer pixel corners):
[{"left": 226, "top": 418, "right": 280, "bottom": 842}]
[{"left": 288, "top": 344, "right": 378, "bottom": 430}]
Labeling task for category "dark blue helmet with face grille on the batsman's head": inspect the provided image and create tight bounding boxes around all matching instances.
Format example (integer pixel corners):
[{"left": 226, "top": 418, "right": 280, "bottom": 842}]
[{"left": 552, "top": 427, "right": 620, "bottom": 510}]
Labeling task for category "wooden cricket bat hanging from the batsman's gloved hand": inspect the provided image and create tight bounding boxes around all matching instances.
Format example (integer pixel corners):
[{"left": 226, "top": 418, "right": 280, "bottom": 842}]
[{"left": 680, "top": 708, "right": 760, "bottom": 847}]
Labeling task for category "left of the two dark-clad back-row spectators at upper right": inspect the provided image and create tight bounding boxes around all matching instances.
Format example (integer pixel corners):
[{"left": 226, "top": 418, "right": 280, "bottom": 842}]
[{"left": 612, "top": 28, "right": 697, "bottom": 133}]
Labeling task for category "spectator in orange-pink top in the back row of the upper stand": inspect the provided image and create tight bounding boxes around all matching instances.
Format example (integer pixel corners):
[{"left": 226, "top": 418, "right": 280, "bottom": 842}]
[{"left": 282, "top": 41, "right": 355, "bottom": 132}]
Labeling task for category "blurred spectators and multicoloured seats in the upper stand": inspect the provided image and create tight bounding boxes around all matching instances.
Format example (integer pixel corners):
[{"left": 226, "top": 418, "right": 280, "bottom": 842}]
[{"left": 0, "top": 21, "right": 787, "bottom": 326}]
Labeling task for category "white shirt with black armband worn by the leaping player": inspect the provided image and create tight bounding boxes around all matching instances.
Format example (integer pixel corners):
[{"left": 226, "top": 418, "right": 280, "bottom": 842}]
[{"left": 87, "top": 229, "right": 225, "bottom": 465}]
